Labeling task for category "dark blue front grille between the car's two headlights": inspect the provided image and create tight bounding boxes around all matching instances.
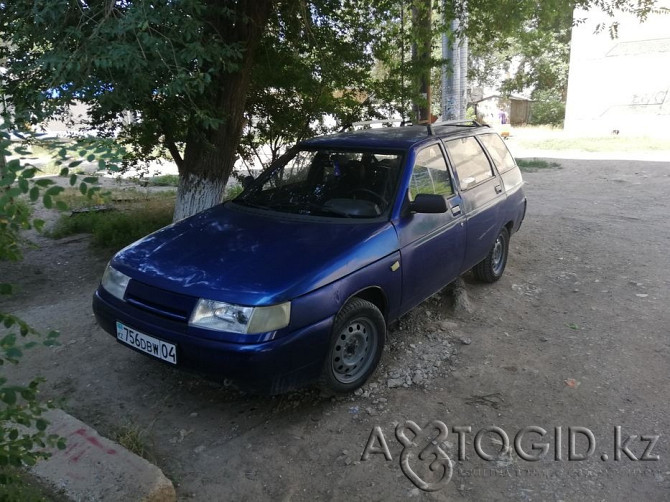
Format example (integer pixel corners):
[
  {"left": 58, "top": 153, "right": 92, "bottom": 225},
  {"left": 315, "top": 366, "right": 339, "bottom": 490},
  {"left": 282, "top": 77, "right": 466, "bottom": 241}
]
[{"left": 125, "top": 280, "right": 198, "bottom": 322}]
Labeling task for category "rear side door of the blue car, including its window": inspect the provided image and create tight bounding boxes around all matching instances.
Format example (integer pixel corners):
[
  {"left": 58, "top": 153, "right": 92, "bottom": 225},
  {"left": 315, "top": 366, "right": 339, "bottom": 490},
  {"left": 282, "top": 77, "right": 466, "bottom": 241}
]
[{"left": 444, "top": 136, "right": 505, "bottom": 271}]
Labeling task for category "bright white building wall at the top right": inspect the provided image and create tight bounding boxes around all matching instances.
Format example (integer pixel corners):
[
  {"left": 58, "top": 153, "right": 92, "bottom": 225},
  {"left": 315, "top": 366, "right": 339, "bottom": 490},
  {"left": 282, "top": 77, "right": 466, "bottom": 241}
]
[{"left": 565, "top": 6, "right": 670, "bottom": 137}]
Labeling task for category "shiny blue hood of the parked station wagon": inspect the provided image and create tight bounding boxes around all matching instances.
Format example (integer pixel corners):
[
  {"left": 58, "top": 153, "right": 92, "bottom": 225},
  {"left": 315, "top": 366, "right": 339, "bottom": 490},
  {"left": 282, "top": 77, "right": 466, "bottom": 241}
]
[{"left": 112, "top": 203, "right": 398, "bottom": 305}]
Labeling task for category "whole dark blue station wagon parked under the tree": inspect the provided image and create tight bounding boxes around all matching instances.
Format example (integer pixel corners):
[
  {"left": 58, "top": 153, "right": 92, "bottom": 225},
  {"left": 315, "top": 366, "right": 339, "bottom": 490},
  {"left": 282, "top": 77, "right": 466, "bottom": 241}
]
[{"left": 93, "top": 122, "right": 526, "bottom": 393}]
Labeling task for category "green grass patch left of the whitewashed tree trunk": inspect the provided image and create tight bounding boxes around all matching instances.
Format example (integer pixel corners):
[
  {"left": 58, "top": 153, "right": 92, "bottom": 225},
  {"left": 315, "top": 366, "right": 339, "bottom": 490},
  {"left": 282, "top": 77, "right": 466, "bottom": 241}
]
[{"left": 48, "top": 190, "right": 175, "bottom": 249}]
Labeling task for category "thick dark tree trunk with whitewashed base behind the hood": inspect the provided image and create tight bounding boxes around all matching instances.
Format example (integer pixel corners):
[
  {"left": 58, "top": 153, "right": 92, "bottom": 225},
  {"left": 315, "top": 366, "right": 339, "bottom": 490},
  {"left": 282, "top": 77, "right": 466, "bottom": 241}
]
[{"left": 174, "top": 0, "right": 273, "bottom": 221}]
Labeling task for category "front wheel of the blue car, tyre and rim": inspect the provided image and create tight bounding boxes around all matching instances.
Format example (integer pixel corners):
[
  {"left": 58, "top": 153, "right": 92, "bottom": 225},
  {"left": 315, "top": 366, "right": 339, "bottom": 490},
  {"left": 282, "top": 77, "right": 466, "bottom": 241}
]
[{"left": 320, "top": 298, "right": 386, "bottom": 393}]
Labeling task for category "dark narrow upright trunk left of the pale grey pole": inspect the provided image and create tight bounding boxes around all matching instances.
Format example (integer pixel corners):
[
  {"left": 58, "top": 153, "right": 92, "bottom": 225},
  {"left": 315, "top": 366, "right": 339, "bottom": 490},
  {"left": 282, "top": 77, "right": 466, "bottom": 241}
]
[{"left": 412, "top": 0, "right": 433, "bottom": 124}]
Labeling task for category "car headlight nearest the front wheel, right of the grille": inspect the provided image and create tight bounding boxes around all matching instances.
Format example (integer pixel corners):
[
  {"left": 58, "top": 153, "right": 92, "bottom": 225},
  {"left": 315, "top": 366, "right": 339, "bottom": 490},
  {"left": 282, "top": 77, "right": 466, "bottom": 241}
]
[{"left": 189, "top": 298, "right": 291, "bottom": 335}]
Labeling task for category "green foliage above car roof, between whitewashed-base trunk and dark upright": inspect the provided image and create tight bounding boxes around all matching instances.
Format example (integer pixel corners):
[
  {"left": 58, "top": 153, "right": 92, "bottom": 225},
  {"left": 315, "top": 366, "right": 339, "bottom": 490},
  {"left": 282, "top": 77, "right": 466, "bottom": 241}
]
[{"left": 239, "top": 1, "right": 400, "bottom": 169}]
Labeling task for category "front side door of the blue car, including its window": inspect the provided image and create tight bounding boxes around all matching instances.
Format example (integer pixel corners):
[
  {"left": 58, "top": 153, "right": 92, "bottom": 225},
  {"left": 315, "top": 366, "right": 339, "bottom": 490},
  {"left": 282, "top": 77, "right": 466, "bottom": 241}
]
[{"left": 394, "top": 143, "right": 465, "bottom": 312}]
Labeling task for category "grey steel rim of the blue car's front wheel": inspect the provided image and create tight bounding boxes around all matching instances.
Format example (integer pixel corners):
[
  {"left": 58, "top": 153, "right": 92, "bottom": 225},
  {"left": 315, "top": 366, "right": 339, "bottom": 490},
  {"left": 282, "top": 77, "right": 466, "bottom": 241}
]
[{"left": 331, "top": 318, "right": 378, "bottom": 384}]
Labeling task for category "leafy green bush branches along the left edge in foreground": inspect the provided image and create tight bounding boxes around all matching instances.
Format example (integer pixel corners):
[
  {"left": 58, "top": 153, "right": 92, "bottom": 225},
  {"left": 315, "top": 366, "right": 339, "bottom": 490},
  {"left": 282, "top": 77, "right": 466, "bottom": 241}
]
[{"left": 0, "top": 129, "right": 119, "bottom": 485}]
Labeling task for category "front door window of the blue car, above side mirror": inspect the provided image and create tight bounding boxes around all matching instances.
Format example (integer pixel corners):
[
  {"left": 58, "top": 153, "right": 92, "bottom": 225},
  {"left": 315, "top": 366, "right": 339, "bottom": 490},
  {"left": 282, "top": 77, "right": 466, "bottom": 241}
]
[{"left": 409, "top": 145, "right": 454, "bottom": 200}]
